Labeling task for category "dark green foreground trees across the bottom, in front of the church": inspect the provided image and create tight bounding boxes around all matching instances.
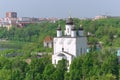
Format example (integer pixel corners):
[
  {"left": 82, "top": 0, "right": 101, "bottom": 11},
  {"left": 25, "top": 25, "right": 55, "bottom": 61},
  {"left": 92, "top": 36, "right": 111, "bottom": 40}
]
[{"left": 0, "top": 50, "right": 119, "bottom": 80}]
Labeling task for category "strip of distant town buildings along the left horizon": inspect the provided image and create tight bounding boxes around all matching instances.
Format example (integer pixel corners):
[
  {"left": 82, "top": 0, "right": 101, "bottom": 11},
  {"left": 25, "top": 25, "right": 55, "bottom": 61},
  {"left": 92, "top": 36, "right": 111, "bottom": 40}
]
[{"left": 0, "top": 12, "right": 58, "bottom": 30}]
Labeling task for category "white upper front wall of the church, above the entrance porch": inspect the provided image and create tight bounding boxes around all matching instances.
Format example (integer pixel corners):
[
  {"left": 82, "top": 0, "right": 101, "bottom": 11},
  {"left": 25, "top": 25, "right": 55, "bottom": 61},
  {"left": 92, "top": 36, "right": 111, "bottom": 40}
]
[{"left": 54, "top": 38, "right": 76, "bottom": 55}]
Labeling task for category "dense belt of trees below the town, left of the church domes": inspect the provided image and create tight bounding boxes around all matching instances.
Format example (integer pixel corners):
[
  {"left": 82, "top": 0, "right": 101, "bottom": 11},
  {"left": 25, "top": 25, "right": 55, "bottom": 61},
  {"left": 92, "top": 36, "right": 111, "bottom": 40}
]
[{"left": 0, "top": 22, "right": 57, "bottom": 42}]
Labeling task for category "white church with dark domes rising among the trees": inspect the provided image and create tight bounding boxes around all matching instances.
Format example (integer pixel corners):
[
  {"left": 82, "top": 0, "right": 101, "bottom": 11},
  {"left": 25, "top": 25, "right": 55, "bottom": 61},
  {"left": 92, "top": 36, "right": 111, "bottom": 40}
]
[{"left": 52, "top": 17, "right": 87, "bottom": 66}]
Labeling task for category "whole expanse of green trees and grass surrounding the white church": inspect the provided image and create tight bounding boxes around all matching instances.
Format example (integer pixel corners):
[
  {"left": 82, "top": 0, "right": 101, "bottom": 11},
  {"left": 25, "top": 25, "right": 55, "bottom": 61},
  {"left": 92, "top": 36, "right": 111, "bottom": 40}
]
[{"left": 0, "top": 18, "right": 120, "bottom": 80}]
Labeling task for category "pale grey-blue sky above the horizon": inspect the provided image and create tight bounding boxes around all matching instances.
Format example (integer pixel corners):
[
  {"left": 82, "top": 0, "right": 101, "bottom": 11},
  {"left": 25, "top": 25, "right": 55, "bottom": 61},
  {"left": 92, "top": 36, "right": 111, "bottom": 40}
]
[{"left": 0, "top": 0, "right": 120, "bottom": 18}]
